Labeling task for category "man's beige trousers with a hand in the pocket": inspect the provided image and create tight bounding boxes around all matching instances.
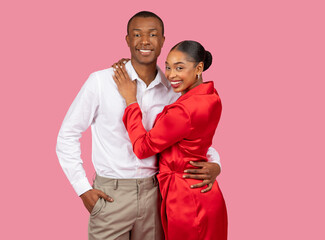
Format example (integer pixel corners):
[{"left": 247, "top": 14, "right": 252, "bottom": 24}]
[{"left": 88, "top": 175, "right": 164, "bottom": 240}]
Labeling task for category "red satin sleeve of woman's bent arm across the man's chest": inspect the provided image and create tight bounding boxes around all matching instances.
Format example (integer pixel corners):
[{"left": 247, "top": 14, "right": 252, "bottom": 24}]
[{"left": 123, "top": 103, "right": 191, "bottom": 159}]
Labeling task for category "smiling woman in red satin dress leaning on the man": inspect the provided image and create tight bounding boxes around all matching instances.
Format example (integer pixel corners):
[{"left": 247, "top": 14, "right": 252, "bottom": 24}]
[{"left": 114, "top": 41, "right": 227, "bottom": 240}]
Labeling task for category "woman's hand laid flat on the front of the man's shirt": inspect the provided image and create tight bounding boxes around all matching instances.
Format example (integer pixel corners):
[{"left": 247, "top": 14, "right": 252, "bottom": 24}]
[{"left": 113, "top": 64, "right": 137, "bottom": 106}]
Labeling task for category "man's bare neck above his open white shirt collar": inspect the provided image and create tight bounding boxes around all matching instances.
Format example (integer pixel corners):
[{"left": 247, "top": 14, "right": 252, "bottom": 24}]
[{"left": 131, "top": 58, "right": 157, "bottom": 86}]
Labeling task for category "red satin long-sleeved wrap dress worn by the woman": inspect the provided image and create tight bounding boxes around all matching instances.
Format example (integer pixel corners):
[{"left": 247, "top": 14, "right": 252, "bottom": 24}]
[{"left": 123, "top": 82, "right": 227, "bottom": 240}]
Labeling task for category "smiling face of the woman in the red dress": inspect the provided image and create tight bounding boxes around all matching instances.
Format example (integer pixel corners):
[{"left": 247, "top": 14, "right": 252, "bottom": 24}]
[{"left": 165, "top": 49, "right": 203, "bottom": 94}]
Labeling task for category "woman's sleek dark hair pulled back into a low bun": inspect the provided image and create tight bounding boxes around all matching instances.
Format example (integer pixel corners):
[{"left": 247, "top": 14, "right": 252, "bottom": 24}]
[{"left": 170, "top": 40, "right": 212, "bottom": 71}]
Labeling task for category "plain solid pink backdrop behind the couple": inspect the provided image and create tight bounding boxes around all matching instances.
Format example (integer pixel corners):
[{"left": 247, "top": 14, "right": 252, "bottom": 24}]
[{"left": 0, "top": 0, "right": 325, "bottom": 240}]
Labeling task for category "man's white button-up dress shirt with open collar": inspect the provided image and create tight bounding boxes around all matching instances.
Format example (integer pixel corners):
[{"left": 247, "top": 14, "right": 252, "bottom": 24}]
[{"left": 56, "top": 61, "right": 220, "bottom": 196}]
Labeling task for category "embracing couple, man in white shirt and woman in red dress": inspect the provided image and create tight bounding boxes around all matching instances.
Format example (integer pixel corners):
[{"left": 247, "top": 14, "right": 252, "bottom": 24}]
[{"left": 57, "top": 11, "right": 227, "bottom": 240}]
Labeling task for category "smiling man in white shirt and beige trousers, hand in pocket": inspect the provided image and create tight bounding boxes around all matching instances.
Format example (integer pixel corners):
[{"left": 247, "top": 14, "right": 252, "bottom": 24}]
[{"left": 57, "top": 12, "right": 220, "bottom": 240}]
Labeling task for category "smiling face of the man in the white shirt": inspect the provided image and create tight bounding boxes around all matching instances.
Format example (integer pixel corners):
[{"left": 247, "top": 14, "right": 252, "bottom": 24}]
[{"left": 126, "top": 17, "right": 165, "bottom": 64}]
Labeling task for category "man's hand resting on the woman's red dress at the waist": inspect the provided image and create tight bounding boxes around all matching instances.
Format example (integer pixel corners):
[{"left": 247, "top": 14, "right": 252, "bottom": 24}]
[{"left": 183, "top": 161, "right": 221, "bottom": 193}]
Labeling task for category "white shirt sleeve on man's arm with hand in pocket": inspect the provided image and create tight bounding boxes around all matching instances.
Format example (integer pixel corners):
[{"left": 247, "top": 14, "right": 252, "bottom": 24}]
[{"left": 56, "top": 73, "right": 99, "bottom": 196}]
